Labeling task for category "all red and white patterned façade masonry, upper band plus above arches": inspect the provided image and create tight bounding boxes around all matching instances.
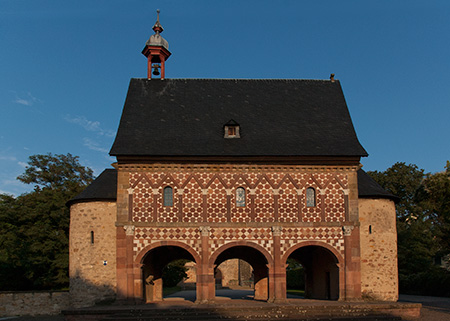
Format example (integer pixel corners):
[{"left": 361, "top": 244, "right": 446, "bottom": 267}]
[{"left": 128, "top": 167, "right": 348, "bottom": 255}]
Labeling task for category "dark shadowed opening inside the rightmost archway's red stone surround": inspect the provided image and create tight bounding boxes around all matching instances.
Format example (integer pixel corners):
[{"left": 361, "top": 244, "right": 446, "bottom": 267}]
[{"left": 287, "top": 245, "right": 339, "bottom": 300}]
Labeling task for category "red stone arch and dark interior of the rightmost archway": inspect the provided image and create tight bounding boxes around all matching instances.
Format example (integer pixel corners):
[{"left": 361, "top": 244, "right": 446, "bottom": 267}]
[{"left": 282, "top": 241, "right": 345, "bottom": 300}]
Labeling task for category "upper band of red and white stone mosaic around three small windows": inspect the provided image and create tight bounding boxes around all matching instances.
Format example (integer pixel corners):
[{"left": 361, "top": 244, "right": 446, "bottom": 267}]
[{"left": 129, "top": 166, "right": 348, "bottom": 223}]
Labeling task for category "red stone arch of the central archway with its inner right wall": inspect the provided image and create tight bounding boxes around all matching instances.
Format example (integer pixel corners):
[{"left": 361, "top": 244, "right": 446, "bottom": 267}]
[{"left": 210, "top": 242, "right": 272, "bottom": 301}]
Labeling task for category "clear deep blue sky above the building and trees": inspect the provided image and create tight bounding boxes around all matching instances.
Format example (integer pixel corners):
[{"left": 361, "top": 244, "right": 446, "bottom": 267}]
[{"left": 0, "top": 0, "right": 450, "bottom": 195}]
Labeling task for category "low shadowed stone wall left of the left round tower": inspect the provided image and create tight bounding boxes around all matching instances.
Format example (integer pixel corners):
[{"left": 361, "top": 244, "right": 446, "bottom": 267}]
[{"left": 0, "top": 291, "right": 70, "bottom": 317}]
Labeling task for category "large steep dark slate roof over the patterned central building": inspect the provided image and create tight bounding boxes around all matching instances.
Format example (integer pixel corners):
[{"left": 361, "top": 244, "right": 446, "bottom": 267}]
[{"left": 110, "top": 79, "right": 367, "bottom": 157}]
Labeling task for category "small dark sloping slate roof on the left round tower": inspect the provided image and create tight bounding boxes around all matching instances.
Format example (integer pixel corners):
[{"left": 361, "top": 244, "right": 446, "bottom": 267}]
[{"left": 66, "top": 168, "right": 117, "bottom": 206}]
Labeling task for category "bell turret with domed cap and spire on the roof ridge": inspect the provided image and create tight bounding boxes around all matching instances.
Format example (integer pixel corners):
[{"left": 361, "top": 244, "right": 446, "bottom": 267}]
[{"left": 142, "top": 10, "right": 171, "bottom": 80}]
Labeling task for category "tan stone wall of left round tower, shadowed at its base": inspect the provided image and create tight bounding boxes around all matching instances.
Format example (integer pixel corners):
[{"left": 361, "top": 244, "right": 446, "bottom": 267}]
[{"left": 69, "top": 202, "right": 117, "bottom": 307}]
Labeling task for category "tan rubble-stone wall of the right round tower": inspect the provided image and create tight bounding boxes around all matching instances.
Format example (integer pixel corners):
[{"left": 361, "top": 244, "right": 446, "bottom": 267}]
[{"left": 359, "top": 199, "right": 398, "bottom": 301}]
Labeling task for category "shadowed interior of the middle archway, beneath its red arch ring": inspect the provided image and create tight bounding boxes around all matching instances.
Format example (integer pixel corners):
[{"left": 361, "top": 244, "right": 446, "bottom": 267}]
[{"left": 214, "top": 245, "right": 269, "bottom": 300}]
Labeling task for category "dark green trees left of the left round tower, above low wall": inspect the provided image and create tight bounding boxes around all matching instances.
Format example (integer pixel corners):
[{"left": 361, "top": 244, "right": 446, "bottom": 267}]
[{"left": 0, "top": 154, "right": 93, "bottom": 290}]
